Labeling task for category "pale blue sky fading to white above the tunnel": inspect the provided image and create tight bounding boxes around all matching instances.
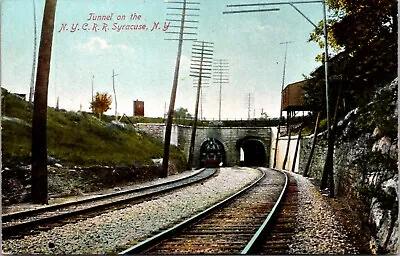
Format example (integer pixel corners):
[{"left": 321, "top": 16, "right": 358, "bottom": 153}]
[{"left": 1, "top": 0, "right": 323, "bottom": 119}]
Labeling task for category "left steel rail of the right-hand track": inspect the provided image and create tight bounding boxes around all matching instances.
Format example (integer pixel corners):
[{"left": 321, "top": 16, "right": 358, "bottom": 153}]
[{"left": 118, "top": 171, "right": 266, "bottom": 254}]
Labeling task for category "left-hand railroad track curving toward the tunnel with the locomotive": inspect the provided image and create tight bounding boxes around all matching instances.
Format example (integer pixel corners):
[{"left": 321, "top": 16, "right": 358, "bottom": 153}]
[{"left": 2, "top": 168, "right": 217, "bottom": 239}]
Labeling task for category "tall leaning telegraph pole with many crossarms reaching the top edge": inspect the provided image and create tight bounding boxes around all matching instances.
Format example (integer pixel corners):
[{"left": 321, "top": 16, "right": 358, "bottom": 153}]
[{"left": 161, "top": 0, "right": 200, "bottom": 177}]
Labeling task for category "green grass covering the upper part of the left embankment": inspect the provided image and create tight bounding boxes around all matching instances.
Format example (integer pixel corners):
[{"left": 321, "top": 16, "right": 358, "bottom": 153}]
[{"left": 2, "top": 90, "right": 184, "bottom": 166}]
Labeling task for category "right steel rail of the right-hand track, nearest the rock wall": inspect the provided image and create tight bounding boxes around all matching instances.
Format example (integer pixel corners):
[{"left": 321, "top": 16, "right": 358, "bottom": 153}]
[{"left": 240, "top": 168, "right": 289, "bottom": 254}]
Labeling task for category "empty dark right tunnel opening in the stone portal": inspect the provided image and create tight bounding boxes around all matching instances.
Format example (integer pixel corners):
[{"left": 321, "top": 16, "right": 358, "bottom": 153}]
[{"left": 237, "top": 137, "right": 266, "bottom": 166}]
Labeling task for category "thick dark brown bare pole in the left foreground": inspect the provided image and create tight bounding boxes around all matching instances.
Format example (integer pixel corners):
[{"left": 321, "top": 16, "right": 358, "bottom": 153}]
[{"left": 31, "top": 0, "right": 57, "bottom": 204}]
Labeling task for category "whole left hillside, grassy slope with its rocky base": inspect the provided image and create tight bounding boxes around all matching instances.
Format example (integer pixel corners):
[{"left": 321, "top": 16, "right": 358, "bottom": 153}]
[{"left": 1, "top": 89, "right": 186, "bottom": 204}]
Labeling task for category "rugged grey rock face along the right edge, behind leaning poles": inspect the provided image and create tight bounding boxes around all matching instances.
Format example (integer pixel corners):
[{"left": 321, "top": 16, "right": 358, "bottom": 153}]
[{"left": 299, "top": 78, "right": 400, "bottom": 253}]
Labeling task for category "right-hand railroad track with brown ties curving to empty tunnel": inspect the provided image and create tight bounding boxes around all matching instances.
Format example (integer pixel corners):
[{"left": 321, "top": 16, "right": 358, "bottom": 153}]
[{"left": 120, "top": 168, "right": 288, "bottom": 254}]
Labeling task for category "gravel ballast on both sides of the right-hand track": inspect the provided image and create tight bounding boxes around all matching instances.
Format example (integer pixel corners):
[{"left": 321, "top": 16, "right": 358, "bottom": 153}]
[{"left": 2, "top": 168, "right": 366, "bottom": 254}]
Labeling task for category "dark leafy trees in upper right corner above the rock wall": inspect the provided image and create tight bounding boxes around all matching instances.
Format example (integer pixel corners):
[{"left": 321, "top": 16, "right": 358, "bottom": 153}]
[{"left": 305, "top": 0, "right": 397, "bottom": 120}]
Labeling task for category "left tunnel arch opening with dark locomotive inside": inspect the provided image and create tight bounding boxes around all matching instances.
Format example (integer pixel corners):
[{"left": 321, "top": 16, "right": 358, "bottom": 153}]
[{"left": 200, "top": 138, "right": 226, "bottom": 168}]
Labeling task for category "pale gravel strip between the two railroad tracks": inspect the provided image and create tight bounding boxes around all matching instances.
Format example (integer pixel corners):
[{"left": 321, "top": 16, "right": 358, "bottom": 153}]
[{"left": 2, "top": 168, "right": 260, "bottom": 254}]
